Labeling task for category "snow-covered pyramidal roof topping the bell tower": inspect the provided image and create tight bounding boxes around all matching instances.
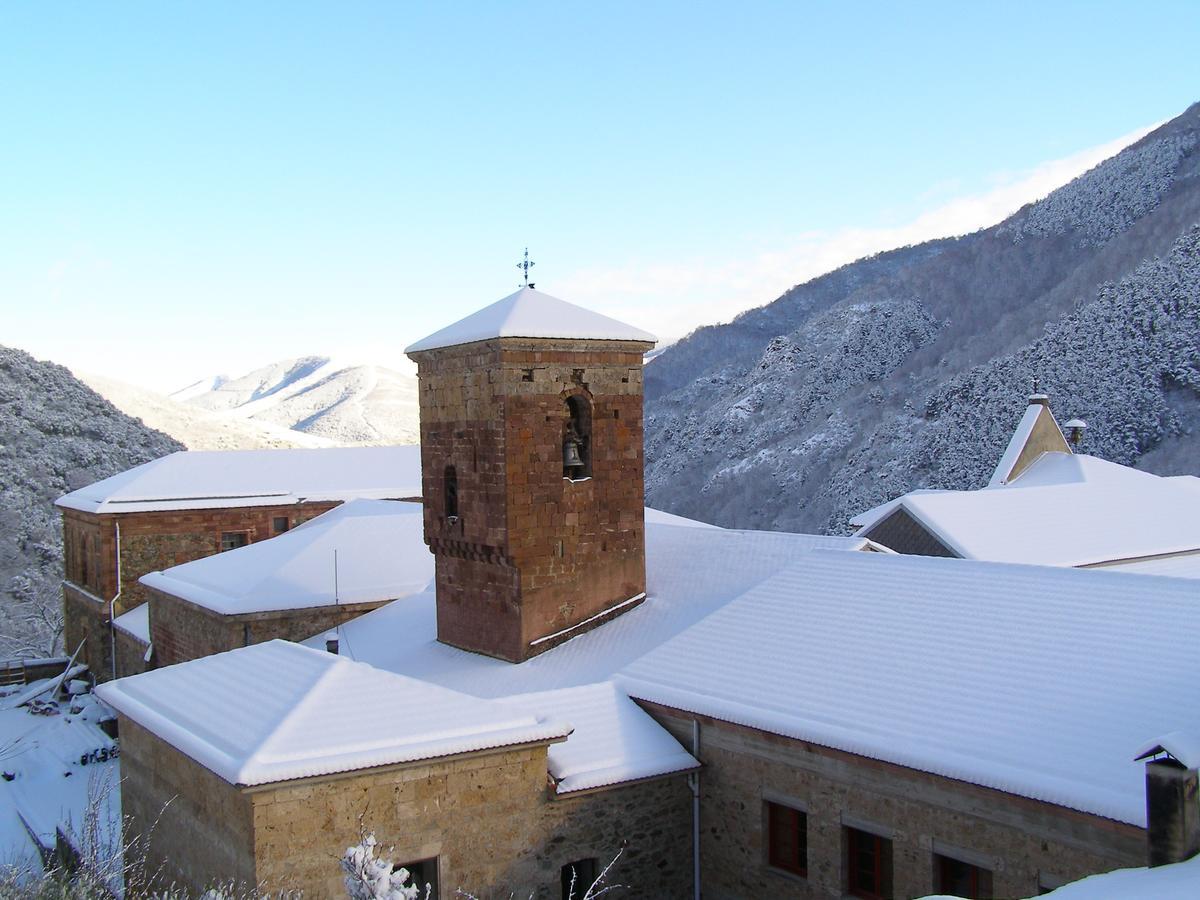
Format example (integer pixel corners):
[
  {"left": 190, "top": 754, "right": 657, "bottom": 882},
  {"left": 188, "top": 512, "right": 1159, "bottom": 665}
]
[{"left": 404, "top": 287, "right": 659, "bottom": 353}]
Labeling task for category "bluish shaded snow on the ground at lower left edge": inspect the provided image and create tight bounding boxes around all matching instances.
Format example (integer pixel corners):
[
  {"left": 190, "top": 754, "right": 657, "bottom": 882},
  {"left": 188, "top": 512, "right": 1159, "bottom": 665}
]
[{"left": 0, "top": 679, "right": 121, "bottom": 870}]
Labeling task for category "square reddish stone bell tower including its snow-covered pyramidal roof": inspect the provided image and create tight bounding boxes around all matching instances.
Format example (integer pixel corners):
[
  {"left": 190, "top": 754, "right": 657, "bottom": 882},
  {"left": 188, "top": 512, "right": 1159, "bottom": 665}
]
[{"left": 406, "top": 287, "right": 656, "bottom": 662}]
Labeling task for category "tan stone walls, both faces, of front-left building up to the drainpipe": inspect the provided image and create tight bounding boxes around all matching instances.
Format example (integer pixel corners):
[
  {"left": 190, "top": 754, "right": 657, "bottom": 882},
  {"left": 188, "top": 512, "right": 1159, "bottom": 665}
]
[{"left": 120, "top": 716, "right": 691, "bottom": 900}]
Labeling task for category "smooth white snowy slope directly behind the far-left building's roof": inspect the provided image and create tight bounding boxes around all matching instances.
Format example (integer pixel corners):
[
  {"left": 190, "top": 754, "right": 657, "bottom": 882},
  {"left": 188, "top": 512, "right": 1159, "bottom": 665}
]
[{"left": 74, "top": 372, "right": 335, "bottom": 450}]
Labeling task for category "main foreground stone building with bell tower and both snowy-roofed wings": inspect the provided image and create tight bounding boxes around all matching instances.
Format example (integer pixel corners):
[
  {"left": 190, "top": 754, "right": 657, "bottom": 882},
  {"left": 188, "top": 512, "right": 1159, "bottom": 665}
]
[{"left": 100, "top": 290, "right": 1200, "bottom": 899}]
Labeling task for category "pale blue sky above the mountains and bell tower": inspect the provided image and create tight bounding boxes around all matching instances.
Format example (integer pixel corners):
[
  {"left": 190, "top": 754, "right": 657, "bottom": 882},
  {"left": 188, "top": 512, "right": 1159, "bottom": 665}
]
[{"left": 0, "top": 1, "right": 1200, "bottom": 389}]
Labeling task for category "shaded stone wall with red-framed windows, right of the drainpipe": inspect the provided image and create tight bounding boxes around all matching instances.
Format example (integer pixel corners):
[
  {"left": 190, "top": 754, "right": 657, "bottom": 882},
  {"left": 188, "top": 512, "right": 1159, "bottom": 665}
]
[{"left": 643, "top": 704, "right": 1145, "bottom": 900}]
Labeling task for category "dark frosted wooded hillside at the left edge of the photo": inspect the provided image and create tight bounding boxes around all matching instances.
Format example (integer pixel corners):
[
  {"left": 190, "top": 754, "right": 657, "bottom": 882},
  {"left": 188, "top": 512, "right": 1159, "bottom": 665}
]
[{"left": 0, "top": 347, "right": 184, "bottom": 656}]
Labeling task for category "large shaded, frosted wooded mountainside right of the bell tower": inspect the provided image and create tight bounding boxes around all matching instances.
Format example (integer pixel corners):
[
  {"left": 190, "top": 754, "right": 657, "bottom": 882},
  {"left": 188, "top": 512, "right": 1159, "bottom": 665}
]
[{"left": 646, "top": 106, "right": 1200, "bottom": 532}]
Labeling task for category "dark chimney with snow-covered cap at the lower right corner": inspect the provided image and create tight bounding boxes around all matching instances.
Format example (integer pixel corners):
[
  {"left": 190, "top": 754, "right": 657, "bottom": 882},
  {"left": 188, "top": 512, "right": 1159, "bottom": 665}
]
[{"left": 1138, "top": 736, "right": 1200, "bottom": 866}]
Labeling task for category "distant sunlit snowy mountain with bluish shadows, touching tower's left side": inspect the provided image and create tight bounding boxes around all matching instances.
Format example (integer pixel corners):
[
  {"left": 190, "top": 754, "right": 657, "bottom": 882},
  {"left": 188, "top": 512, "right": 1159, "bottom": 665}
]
[{"left": 172, "top": 356, "right": 420, "bottom": 444}]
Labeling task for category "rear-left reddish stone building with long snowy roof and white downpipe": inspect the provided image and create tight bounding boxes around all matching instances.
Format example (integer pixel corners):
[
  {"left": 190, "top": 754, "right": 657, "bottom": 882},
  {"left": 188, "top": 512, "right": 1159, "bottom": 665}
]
[{"left": 55, "top": 446, "right": 420, "bottom": 679}]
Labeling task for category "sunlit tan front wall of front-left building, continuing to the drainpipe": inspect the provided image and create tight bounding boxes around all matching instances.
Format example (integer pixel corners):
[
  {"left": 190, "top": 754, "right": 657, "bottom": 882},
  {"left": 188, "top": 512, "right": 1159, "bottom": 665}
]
[{"left": 250, "top": 748, "right": 691, "bottom": 900}]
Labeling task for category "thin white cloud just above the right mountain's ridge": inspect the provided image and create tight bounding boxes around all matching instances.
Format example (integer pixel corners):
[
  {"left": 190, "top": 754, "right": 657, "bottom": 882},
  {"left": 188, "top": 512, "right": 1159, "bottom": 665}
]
[{"left": 560, "top": 122, "right": 1160, "bottom": 342}]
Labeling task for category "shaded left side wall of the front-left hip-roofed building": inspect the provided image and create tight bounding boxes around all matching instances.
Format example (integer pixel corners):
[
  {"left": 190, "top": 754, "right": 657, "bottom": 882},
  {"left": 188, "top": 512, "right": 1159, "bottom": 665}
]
[{"left": 120, "top": 715, "right": 258, "bottom": 896}]
